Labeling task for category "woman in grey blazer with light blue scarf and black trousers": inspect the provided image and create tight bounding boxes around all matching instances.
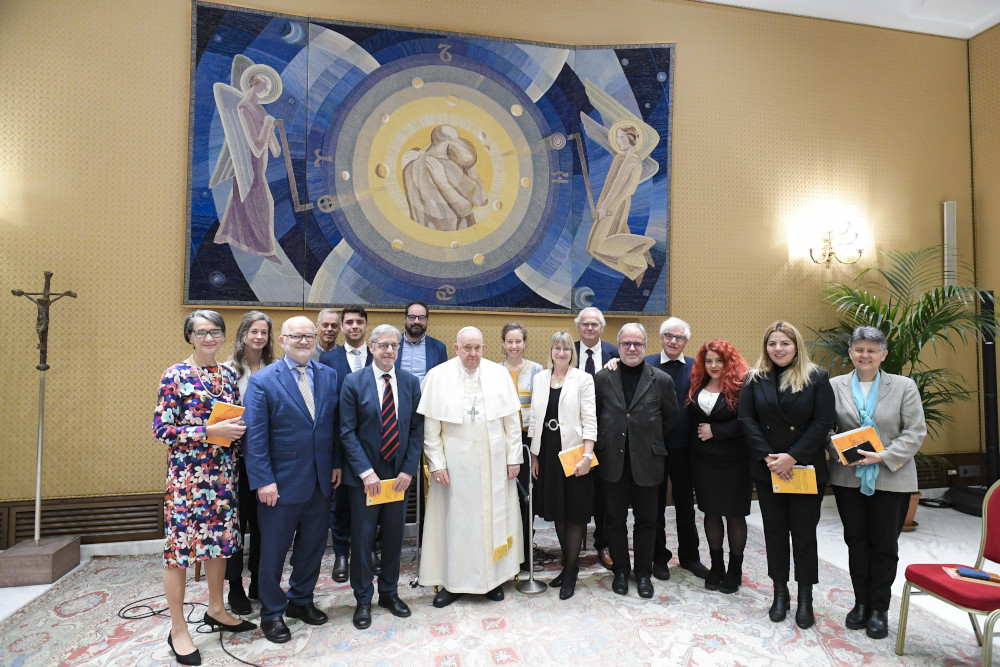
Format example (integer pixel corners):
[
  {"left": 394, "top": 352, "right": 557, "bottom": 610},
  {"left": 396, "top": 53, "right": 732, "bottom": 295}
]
[{"left": 829, "top": 327, "right": 927, "bottom": 639}]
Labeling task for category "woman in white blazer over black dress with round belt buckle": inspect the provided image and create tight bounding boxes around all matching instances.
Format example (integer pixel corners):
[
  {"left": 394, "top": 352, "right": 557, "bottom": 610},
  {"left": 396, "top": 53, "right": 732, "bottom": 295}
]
[{"left": 528, "top": 332, "right": 597, "bottom": 600}]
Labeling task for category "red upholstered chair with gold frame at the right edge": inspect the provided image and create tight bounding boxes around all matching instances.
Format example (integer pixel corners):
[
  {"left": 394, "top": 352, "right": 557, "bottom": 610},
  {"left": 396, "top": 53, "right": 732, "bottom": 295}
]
[{"left": 896, "top": 482, "right": 1000, "bottom": 667}]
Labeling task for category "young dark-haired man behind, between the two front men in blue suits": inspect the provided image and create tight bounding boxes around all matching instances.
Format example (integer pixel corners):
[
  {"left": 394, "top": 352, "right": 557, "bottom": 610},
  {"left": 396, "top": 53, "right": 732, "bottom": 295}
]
[{"left": 319, "top": 306, "right": 372, "bottom": 583}]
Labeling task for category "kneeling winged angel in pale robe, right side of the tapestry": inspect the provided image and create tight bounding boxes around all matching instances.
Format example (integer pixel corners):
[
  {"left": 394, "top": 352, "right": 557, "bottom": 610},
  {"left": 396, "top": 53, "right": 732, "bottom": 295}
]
[{"left": 580, "top": 80, "right": 660, "bottom": 285}]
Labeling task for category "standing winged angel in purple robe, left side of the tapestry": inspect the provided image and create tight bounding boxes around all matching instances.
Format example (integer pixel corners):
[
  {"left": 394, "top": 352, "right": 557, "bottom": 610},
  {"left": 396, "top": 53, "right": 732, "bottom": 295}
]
[{"left": 208, "top": 54, "right": 282, "bottom": 262}]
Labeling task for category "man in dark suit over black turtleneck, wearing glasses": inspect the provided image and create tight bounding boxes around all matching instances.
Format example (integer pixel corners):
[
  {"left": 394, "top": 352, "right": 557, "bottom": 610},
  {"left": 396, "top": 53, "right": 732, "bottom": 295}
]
[{"left": 594, "top": 322, "right": 678, "bottom": 598}]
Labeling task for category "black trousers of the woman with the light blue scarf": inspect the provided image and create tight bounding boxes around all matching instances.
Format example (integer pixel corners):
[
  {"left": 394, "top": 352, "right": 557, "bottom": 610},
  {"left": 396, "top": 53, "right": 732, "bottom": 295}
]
[{"left": 833, "top": 486, "right": 910, "bottom": 611}]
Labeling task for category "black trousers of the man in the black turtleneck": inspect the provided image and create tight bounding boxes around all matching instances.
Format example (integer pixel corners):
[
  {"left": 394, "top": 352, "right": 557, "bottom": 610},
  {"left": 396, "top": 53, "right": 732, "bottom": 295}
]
[{"left": 604, "top": 457, "right": 659, "bottom": 577}]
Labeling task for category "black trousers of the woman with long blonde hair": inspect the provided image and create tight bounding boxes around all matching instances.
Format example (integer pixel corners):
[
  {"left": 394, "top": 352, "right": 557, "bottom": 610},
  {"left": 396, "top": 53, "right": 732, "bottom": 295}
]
[{"left": 754, "top": 480, "right": 823, "bottom": 585}]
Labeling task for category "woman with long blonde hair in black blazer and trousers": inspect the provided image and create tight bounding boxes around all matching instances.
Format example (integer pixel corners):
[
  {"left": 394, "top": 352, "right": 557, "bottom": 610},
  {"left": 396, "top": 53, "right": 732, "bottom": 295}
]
[{"left": 739, "top": 321, "right": 836, "bottom": 629}]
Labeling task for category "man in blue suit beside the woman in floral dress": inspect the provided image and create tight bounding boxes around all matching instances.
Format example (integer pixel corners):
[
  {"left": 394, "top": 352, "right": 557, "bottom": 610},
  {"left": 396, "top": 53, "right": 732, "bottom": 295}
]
[{"left": 243, "top": 316, "right": 341, "bottom": 643}]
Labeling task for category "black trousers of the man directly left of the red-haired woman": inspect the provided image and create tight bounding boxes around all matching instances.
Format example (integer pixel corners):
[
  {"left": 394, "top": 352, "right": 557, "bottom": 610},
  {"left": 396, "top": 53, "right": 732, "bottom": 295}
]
[{"left": 653, "top": 447, "right": 701, "bottom": 566}]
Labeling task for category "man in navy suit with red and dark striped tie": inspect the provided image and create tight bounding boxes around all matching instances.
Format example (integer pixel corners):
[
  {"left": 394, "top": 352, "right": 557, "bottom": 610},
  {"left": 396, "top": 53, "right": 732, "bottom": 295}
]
[{"left": 340, "top": 324, "right": 424, "bottom": 630}]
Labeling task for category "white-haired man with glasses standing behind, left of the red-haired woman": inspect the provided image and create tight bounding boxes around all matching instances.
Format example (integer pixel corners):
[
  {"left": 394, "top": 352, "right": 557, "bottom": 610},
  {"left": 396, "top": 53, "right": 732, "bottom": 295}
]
[{"left": 646, "top": 317, "right": 708, "bottom": 580}]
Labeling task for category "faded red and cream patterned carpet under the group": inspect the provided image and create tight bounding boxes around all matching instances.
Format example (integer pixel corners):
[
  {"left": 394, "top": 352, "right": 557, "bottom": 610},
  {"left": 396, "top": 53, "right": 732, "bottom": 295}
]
[{"left": 0, "top": 522, "right": 980, "bottom": 667}]
